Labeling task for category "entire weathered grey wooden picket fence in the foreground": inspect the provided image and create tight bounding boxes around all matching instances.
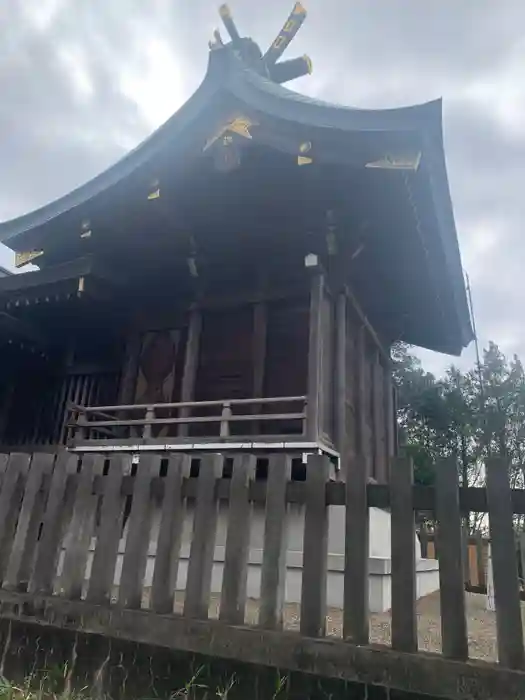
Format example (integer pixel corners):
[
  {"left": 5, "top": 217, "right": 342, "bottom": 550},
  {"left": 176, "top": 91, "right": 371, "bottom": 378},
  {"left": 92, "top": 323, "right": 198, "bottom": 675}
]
[{"left": 0, "top": 452, "right": 525, "bottom": 700}]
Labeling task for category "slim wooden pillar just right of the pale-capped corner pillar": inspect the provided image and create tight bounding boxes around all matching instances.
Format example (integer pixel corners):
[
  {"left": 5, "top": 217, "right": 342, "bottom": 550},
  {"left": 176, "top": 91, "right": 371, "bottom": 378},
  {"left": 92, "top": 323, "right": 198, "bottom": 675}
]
[{"left": 334, "top": 291, "right": 348, "bottom": 476}]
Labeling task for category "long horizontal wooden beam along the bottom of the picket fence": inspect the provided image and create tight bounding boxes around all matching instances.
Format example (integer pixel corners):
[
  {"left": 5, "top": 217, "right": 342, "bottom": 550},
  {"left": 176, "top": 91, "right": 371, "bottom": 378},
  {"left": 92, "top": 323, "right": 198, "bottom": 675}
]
[{"left": 0, "top": 590, "right": 525, "bottom": 700}]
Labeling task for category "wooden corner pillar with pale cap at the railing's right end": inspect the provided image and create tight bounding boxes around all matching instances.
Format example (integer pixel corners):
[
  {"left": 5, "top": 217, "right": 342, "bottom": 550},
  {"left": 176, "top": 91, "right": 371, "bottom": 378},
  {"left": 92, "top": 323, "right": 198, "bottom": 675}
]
[{"left": 306, "top": 269, "right": 324, "bottom": 442}]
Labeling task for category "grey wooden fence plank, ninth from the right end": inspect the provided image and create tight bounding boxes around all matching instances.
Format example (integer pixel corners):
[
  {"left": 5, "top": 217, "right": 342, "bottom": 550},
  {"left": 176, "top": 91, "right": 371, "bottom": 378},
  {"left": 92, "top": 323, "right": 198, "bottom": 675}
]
[{"left": 150, "top": 454, "right": 191, "bottom": 613}]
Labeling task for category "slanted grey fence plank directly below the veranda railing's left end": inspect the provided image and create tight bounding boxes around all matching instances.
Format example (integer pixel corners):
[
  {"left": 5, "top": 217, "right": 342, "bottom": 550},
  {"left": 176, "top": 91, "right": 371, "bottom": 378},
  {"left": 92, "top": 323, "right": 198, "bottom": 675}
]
[{"left": 29, "top": 452, "right": 78, "bottom": 595}]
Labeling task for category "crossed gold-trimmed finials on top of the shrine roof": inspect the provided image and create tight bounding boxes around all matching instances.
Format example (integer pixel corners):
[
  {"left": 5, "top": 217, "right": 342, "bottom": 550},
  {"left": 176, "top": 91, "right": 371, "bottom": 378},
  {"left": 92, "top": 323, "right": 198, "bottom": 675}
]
[{"left": 210, "top": 2, "right": 312, "bottom": 83}]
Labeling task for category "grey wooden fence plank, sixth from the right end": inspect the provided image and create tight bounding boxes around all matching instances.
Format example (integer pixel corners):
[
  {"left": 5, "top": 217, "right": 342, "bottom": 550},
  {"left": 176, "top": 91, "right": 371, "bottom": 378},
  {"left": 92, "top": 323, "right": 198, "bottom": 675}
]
[{"left": 259, "top": 454, "right": 291, "bottom": 629}]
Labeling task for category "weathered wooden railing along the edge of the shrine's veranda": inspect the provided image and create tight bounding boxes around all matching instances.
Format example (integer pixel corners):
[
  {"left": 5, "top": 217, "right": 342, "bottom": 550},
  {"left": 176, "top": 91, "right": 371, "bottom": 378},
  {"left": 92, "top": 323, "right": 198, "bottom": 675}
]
[{"left": 68, "top": 396, "right": 306, "bottom": 440}]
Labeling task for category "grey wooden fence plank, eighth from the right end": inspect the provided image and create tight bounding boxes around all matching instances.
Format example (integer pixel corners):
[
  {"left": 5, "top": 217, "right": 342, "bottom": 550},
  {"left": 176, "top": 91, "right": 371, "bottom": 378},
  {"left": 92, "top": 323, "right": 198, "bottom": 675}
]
[{"left": 184, "top": 455, "right": 223, "bottom": 619}]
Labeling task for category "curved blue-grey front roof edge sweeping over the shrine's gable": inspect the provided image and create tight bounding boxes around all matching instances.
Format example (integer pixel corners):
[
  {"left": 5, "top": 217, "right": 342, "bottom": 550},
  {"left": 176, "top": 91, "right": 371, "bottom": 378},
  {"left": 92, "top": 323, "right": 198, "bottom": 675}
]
[{"left": 0, "top": 46, "right": 441, "bottom": 243}]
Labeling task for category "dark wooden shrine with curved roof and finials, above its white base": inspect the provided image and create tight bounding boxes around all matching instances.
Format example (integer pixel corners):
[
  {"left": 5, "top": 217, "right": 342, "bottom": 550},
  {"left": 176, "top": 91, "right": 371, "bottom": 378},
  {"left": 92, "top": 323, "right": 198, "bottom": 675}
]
[{"left": 0, "top": 4, "right": 472, "bottom": 481}]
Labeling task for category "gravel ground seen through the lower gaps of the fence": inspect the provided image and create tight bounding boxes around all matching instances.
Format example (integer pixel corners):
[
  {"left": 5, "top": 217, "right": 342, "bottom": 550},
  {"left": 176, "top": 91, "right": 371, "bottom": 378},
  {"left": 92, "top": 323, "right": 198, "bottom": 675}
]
[{"left": 167, "top": 592, "right": 525, "bottom": 661}]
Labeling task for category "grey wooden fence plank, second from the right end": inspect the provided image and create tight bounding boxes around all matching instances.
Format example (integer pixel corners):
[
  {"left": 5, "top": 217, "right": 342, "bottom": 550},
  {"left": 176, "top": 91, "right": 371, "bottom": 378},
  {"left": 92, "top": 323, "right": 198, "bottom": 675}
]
[{"left": 436, "top": 459, "right": 468, "bottom": 660}]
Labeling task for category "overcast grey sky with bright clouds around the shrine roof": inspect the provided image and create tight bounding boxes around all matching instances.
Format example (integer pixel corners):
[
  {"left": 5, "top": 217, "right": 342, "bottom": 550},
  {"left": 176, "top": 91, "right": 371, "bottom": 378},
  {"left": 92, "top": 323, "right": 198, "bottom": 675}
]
[{"left": 0, "top": 0, "right": 525, "bottom": 371}]
